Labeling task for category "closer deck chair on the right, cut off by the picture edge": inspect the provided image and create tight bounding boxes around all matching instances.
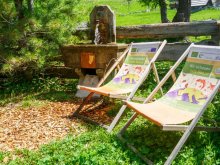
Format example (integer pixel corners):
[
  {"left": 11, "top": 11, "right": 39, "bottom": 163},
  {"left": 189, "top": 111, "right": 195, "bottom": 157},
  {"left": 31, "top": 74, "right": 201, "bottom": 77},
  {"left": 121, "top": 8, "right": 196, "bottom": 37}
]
[{"left": 117, "top": 44, "right": 220, "bottom": 164}]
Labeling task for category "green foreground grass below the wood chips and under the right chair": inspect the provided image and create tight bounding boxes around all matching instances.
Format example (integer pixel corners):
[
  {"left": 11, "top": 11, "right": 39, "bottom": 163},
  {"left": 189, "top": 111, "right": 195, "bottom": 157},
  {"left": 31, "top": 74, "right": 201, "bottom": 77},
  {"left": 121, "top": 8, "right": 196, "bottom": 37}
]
[{"left": 0, "top": 103, "right": 220, "bottom": 164}]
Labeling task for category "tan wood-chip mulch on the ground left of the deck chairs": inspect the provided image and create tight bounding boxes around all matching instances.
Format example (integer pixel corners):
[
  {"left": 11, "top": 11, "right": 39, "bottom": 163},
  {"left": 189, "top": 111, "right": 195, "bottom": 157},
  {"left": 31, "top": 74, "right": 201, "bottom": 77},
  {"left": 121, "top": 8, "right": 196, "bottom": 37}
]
[{"left": 0, "top": 101, "right": 112, "bottom": 151}]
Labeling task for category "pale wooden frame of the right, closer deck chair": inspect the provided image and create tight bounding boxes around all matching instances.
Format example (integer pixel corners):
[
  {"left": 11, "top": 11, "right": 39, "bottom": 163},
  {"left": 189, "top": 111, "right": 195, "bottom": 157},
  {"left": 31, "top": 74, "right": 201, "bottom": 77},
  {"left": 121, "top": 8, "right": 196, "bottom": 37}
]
[{"left": 117, "top": 44, "right": 220, "bottom": 165}]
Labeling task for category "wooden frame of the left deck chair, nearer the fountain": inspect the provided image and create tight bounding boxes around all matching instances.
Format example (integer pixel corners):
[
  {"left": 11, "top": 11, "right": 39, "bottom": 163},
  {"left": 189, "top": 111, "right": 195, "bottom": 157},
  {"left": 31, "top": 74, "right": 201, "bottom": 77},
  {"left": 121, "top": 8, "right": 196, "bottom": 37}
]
[{"left": 71, "top": 40, "right": 167, "bottom": 132}]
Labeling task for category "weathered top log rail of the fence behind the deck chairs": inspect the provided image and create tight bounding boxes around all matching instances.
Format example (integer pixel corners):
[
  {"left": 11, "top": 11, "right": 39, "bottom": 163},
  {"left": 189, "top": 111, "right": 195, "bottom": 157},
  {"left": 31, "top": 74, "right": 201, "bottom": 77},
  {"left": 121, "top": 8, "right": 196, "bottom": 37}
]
[{"left": 75, "top": 20, "right": 219, "bottom": 39}]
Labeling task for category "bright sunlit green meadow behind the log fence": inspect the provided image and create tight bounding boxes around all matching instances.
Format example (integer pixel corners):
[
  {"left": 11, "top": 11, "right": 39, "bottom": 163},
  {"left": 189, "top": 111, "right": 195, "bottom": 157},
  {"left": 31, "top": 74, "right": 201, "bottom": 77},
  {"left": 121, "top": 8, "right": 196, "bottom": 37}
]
[{"left": 83, "top": 0, "right": 220, "bottom": 26}]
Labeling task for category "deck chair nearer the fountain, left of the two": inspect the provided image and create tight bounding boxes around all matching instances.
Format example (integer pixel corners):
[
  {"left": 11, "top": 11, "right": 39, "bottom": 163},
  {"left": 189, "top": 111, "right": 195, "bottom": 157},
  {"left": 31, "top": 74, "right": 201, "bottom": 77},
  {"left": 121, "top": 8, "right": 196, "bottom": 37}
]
[{"left": 72, "top": 40, "right": 166, "bottom": 132}]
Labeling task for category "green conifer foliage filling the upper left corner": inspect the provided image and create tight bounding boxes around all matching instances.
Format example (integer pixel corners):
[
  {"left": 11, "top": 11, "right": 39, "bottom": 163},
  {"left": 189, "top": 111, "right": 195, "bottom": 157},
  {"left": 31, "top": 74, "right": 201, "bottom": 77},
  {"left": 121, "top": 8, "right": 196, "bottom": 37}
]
[{"left": 0, "top": 0, "right": 88, "bottom": 74}]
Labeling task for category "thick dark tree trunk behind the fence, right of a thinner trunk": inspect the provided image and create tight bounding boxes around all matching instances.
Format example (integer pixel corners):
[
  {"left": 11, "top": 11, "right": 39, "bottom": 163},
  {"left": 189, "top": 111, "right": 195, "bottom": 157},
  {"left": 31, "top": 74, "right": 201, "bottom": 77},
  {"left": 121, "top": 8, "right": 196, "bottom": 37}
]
[{"left": 173, "top": 0, "right": 191, "bottom": 22}]
